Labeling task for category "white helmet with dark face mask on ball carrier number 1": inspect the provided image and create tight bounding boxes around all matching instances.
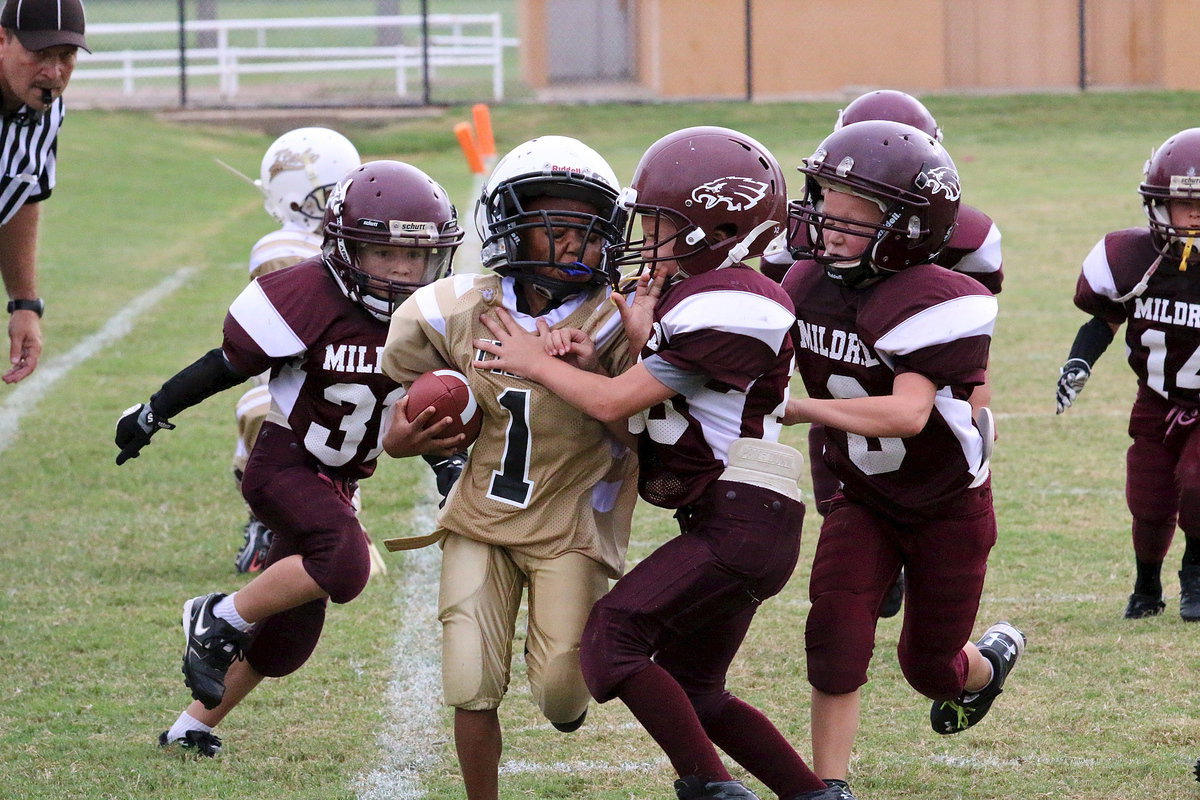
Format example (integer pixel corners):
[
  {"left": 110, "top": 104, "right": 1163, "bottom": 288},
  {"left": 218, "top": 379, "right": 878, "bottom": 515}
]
[{"left": 475, "top": 136, "right": 623, "bottom": 299}]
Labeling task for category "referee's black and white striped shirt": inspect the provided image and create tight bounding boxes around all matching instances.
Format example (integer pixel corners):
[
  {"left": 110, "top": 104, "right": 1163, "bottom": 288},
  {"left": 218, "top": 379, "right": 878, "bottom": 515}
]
[{"left": 0, "top": 97, "right": 66, "bottom": 225}]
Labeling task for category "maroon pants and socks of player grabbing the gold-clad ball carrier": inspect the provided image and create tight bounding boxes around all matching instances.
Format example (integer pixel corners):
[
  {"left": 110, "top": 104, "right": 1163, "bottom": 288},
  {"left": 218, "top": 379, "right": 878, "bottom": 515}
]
[{"left": 580, "top": 481, "right": 822, "bottom": 796}]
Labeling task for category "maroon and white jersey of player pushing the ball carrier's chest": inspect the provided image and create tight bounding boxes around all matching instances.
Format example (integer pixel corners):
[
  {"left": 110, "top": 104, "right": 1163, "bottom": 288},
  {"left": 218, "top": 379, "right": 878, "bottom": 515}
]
[{"left": 629, "top": 266, "right": 796, "bottom": 509}]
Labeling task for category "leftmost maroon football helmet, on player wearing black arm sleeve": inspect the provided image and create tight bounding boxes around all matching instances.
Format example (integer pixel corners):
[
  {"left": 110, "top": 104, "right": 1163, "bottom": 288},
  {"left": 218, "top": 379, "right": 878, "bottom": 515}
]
[{"left": 322, "top": 161, "right": 463, "bottom": 320}]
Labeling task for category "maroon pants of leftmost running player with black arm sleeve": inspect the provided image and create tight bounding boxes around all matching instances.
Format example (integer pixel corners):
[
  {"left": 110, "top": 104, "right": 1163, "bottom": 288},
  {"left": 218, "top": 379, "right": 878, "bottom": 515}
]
[{"left": 234, "top": 422, "right": 371, "bottom": 678}]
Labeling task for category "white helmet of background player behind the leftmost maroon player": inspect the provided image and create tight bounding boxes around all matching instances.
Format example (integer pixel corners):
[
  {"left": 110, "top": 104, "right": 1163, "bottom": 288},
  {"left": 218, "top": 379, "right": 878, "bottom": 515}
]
[{"left": 254, "top": 127, "right": 362, "bottom": 233}]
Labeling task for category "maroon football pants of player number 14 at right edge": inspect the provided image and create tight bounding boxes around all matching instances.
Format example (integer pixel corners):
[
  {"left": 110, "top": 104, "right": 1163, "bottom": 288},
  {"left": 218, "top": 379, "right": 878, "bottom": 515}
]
[{"left": 1126, "top": 387, "right": 1200, "bottom": 564}]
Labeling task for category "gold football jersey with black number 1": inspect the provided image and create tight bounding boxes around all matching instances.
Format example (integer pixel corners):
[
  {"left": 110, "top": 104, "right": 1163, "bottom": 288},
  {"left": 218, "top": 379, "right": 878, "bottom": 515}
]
[{"left": 383, "top": 273, "right": 637, "bottom": 577}]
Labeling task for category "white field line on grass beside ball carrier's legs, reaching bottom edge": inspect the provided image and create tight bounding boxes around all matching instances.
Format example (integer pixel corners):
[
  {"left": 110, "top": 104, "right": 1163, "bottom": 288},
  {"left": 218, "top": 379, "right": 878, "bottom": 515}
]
[{"left": 355, "top": 501, "right": 448, "bottom": 800}]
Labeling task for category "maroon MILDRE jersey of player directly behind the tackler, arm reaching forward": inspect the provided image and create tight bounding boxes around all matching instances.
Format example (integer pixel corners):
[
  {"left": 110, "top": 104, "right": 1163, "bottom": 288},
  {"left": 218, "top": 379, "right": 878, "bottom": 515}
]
[{"left": 784, "top": 261, "right": 996, "bottom": 519}]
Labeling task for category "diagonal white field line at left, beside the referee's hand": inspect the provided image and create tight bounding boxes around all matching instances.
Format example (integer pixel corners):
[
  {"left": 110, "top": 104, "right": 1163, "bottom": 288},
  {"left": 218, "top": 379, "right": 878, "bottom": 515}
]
[{"left": 0, "top": 266, "right": 196, "bottom": 452}]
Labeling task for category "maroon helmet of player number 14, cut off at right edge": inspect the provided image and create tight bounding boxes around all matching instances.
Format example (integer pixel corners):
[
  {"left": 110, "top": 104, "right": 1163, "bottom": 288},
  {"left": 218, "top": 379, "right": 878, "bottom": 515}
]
[{"left": 1138, "top": 128, "right": 1200, "bottom": 258}]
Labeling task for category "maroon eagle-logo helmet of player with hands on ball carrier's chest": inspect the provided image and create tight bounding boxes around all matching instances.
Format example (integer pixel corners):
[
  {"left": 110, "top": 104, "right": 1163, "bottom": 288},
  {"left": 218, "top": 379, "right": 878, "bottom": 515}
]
[{"left": 612, "top": 126, "right": 787, "bottom": 276}]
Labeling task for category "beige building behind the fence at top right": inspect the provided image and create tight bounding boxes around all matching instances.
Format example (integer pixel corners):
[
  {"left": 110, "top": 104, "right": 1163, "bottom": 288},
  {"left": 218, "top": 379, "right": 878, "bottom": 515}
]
[{"left": 518, "top": 0, "right": 1200, "bottom": 100}]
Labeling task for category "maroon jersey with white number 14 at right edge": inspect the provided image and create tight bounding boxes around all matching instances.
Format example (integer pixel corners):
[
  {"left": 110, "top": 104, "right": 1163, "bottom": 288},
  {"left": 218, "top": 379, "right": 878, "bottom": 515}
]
[{"left": 1075, "top": 228, "right": 1200, "bottom": 408}]
